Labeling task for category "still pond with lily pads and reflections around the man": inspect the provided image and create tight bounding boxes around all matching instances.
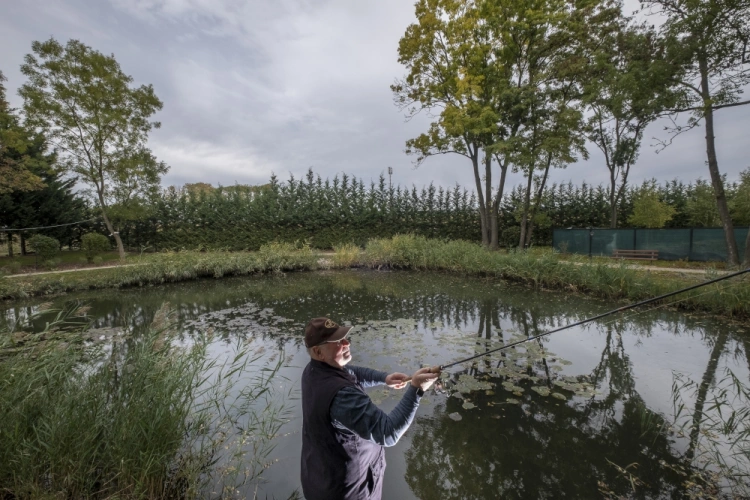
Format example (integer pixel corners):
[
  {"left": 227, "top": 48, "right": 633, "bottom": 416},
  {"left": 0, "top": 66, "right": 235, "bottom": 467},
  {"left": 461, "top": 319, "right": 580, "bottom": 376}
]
[{"left": 5, "top": 270, "right": 750, "bottom": 499}]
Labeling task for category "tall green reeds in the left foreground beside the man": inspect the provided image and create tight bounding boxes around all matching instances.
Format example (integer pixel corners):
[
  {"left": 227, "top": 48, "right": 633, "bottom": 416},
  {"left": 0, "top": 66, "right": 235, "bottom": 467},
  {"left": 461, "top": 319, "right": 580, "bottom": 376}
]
[{"left": 0, "top": 302, "right": 286, "bottom": 498}]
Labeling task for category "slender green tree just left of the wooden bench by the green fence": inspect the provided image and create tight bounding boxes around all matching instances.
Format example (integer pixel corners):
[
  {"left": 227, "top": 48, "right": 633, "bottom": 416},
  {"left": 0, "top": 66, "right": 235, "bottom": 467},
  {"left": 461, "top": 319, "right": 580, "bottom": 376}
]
[{"left": 584, "top": 22, "right": 674, "bottom": 228}]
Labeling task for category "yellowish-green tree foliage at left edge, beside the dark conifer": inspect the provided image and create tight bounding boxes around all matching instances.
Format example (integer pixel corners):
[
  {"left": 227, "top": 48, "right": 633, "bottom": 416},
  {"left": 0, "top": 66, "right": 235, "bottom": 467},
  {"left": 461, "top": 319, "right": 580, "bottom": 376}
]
[{"left": 0, "top": 71, "right": 44, "bottom": 195}]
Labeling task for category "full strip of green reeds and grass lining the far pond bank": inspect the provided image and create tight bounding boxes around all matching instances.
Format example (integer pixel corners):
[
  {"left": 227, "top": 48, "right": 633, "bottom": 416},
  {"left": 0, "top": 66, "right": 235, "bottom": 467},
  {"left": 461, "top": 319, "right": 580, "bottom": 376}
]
[{"left": 0, "top": 235, "right": 750, "bottom": 318}]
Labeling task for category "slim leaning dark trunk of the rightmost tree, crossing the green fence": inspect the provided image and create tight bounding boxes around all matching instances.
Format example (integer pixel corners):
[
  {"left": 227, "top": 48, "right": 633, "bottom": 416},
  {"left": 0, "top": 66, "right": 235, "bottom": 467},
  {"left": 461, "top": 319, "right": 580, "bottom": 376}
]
[{"left": 698, "top": 58, "right": 740, "bottom": 266}]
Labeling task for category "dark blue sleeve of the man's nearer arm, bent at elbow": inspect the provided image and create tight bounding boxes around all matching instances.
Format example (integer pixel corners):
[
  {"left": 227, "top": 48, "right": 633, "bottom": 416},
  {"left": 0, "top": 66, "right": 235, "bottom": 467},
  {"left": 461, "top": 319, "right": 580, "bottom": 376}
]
[{"left": 330, "top": 384, "right": 424, "bottom": 446}]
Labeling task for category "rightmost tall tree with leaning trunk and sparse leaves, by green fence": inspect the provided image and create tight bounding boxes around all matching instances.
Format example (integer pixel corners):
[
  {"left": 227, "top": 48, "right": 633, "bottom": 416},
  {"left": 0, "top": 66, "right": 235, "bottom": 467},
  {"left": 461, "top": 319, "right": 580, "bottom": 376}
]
[{"left": 645, "top": 0, "right": 750, "bottom": 265}]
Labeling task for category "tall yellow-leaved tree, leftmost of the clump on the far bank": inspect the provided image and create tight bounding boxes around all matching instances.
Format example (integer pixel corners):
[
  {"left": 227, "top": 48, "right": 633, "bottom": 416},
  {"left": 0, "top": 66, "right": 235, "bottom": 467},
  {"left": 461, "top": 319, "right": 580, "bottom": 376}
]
[{"left": 391, "top": 0, "right": 504, "bottom": 248}]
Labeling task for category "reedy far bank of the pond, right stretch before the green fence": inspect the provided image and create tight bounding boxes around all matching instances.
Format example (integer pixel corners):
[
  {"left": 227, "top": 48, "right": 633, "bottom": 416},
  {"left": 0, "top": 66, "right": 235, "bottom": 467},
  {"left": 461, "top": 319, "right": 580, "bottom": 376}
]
[{"left": 359, "top": 235, "right": 750, "bottom": 318}]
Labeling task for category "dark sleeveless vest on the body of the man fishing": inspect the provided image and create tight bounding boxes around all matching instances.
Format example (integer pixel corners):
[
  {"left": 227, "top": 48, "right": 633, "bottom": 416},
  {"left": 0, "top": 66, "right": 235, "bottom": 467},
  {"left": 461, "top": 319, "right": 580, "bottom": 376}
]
[{"left": 301, "top": 360, "right": 385, "bottom": 500}]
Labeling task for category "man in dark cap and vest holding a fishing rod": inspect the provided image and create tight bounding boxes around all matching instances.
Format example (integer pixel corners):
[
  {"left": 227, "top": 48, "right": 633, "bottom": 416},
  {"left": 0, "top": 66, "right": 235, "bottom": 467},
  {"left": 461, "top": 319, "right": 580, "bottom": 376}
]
[{"left": 301, "top": 318, "right": 438, "bottom": 500}]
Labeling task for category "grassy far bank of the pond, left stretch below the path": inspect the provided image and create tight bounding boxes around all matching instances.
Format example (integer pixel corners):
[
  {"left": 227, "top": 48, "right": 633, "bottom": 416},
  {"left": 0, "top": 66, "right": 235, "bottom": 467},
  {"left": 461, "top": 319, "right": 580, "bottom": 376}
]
[{"left": 0, "top": 243, "right": 317, "bottom": 300}]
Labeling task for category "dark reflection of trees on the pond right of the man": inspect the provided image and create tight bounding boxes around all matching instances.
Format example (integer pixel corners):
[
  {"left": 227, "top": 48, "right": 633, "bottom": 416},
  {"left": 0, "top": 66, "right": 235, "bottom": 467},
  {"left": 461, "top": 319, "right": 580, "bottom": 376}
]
[{"left": 406, "top": 302, "right": 692, "bottom": 499}]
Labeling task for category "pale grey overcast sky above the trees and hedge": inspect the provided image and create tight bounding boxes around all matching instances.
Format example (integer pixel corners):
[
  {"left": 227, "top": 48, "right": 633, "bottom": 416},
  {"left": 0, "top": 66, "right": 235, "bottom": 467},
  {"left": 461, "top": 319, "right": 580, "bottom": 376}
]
[{"left": 0, "top": 0, "right": 750, "bottom": 193}]
